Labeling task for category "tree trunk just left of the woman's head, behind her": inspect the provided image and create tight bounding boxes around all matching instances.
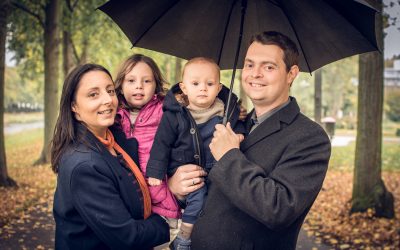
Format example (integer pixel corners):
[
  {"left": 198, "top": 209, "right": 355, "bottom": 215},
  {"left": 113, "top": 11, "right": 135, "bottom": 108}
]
[{"left": 36, "top": 0, "right": 60, "bottom": 164}]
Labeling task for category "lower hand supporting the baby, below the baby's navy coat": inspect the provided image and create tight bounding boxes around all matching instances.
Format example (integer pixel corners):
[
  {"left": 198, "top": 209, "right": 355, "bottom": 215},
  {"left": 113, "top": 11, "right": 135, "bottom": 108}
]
[{"left": 168, "top": 164, "right": 207, "bottom": 200}]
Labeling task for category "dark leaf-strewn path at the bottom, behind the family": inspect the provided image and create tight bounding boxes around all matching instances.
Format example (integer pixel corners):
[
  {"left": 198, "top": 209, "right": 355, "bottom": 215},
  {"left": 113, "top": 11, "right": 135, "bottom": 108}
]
[{"left": 0, "top": 202, "right": 333, "bottom": 250}]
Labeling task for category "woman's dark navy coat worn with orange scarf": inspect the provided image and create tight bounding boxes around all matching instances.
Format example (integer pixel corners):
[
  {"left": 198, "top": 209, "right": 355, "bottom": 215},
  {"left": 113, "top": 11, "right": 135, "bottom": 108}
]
[{"left": 53, "top": 126, "right": 169, "bottom": 249}]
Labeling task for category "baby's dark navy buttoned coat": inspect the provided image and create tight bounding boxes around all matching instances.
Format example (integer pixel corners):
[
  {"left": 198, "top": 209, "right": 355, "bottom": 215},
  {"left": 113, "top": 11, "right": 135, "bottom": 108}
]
[{"left": 146, "top": 84, "right": 245, "bottom": 180}]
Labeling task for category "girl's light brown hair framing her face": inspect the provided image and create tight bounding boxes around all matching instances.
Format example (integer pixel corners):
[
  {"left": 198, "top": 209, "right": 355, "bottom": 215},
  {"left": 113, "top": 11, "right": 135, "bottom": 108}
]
[{"left": 115, "top": 54, "right": 167, "bottom": 109}]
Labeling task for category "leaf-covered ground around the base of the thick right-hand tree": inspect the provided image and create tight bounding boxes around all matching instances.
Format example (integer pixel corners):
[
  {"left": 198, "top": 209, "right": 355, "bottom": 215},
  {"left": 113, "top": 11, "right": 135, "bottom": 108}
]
[{"left": 303, "top": 171, "right": 400, "bottom": 250}]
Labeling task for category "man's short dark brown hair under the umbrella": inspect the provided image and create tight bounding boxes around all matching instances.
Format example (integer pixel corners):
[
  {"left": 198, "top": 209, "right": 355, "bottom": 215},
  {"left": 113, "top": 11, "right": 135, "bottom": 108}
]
[{"left": 250, "top": 31, "right": 299, "bottom": 72}]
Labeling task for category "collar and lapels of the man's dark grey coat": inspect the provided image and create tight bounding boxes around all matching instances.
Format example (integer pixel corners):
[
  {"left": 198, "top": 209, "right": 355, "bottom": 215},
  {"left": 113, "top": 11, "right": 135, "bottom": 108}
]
[{"left": 240, "top": 97, "right": 300, "bottom": 152}]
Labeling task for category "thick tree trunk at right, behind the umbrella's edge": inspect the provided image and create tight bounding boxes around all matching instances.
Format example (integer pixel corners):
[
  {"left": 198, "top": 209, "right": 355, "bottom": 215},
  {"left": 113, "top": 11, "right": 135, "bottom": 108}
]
[{"left": 351, "top": 0, "right": 394, "bottom": 218}]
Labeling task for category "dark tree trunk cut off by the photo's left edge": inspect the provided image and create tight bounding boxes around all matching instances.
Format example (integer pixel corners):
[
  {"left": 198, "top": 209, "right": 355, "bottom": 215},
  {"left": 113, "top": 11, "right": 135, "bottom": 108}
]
[{"left": 0, "top": 0, "right": 16, "bottom": 187}]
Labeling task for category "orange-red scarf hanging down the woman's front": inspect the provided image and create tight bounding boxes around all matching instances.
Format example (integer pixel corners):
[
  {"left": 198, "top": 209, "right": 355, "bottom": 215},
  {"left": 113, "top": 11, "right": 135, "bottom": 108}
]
[{"left": 96, "top": 129, "right": 151, "bottom": 219}]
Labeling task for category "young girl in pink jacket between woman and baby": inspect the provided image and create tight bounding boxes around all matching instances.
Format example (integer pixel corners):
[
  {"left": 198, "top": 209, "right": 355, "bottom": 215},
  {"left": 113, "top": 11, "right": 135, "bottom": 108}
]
[{"left": 115, "top": 54, "right": 181, "bottom": 225}]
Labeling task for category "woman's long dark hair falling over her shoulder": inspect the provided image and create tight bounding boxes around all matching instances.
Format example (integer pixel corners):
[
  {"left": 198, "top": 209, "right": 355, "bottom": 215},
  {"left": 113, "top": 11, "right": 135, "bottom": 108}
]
[{"left": 51, "top": 64, "right": 112, "bottom": 173}]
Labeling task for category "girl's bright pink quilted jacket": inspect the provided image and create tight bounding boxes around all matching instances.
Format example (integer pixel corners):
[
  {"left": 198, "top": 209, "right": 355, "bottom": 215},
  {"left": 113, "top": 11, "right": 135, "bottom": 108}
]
[{"left": 116, "top": 95, "right": 181, "bottom": 218}]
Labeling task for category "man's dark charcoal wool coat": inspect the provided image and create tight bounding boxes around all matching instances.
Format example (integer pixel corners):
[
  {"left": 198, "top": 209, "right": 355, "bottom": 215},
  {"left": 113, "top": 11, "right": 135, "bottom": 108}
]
[{"left": 192, "top": 98, "right": 331, "bottom": 250}]
